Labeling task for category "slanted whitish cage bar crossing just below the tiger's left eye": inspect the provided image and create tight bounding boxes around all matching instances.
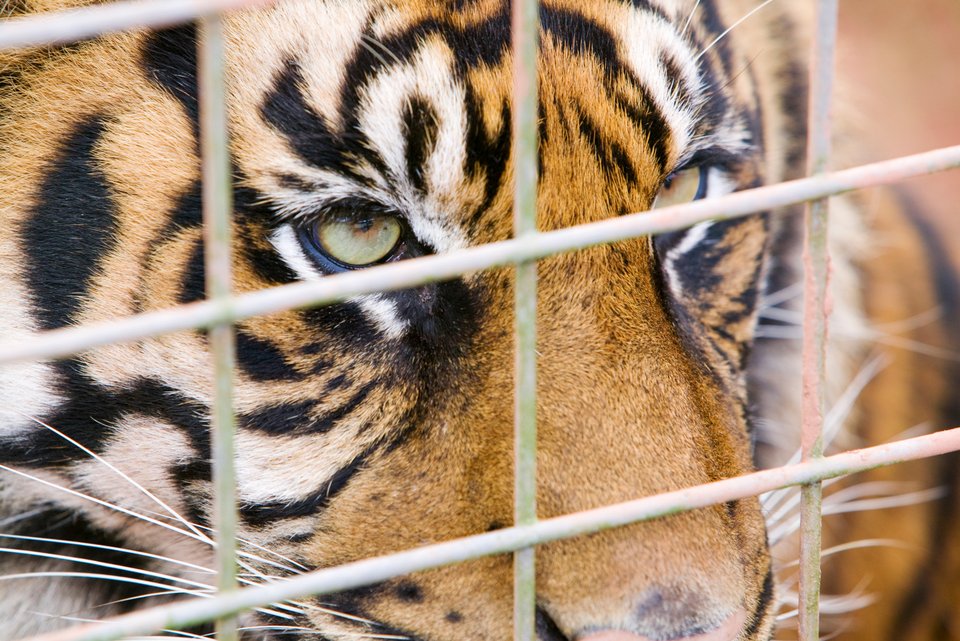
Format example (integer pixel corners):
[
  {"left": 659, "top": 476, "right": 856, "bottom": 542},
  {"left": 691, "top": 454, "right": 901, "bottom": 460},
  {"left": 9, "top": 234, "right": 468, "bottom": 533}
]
[{"left": 0, "top": 145, "right": 960, "bottom": 365}]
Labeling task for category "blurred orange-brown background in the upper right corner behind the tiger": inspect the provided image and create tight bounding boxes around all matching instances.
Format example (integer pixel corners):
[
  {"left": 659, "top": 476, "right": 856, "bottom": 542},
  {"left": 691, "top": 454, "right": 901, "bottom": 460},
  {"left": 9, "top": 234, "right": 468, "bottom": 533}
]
[{"left": 836, "top": 0, "right": 960, "bottom": 242}]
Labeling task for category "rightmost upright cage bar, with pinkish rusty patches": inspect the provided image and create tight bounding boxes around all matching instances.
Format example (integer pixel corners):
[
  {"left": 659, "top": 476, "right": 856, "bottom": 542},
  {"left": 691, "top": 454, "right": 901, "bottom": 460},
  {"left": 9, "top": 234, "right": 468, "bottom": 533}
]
[{"left": 798, "top": 0, "right": 838, "bottom": 641}]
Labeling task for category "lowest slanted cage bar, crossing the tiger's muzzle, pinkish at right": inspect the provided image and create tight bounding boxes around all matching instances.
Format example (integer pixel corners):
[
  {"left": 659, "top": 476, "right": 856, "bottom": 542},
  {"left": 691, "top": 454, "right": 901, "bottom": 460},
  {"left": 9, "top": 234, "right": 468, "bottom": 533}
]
[{"left": 30, "top": 428, "right": 960, "bottom": 641}]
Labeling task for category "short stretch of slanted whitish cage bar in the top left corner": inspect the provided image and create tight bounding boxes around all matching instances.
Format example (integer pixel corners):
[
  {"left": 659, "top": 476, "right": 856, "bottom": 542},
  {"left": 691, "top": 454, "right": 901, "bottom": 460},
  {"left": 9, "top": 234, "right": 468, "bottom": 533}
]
[{"left": 0, "top": 0, "right": 273, "bottom": 51}]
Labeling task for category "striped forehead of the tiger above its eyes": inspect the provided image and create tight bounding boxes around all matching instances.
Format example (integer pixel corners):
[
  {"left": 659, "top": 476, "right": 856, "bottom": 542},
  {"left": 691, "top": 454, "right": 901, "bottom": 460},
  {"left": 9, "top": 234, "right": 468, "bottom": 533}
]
[{"left": 226, "top": 0, "right": 700, "bottom": 242}]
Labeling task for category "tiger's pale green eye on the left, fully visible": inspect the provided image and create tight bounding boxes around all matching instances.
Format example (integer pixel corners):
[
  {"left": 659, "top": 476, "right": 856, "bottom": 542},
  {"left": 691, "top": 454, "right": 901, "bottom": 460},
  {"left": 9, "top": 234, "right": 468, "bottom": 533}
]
[{"left": 314, "top": 216, "right": 402, "bottom": 267}]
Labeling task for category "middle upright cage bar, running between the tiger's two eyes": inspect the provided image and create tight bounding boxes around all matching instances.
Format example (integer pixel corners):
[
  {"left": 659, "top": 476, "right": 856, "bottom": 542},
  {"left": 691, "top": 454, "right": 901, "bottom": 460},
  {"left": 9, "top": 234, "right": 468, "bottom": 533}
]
[{"left": 512, "top": 0, "right": 540, "bottom": 641}]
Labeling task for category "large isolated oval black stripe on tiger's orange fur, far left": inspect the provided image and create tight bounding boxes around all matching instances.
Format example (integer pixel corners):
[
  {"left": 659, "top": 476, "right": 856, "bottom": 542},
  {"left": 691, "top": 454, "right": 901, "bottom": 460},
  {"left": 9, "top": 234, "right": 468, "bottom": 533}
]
[{"left": 21, "top": 117, "right": 117, "bottom": 329}]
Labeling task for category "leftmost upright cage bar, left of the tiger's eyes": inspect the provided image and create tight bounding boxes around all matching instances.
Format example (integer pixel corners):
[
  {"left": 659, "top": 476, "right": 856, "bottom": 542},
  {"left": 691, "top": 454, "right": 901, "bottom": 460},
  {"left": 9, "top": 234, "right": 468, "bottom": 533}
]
[{"left": 199, "top": 15, "right": 238, "bottom": 641}]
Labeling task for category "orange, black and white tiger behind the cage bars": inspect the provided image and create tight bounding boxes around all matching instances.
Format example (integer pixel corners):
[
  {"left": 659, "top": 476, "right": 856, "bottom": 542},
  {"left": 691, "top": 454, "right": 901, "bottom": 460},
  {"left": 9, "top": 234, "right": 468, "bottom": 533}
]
[{"left": 0, "top": 0, "right": 960, "bottom": 641}]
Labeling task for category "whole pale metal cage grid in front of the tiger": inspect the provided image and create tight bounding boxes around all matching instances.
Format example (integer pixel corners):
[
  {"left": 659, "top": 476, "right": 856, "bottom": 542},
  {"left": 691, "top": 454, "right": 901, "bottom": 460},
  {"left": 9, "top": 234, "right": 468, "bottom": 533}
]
[{"left": 0, "top": 0, "right": 960, "bottom": 641}]
